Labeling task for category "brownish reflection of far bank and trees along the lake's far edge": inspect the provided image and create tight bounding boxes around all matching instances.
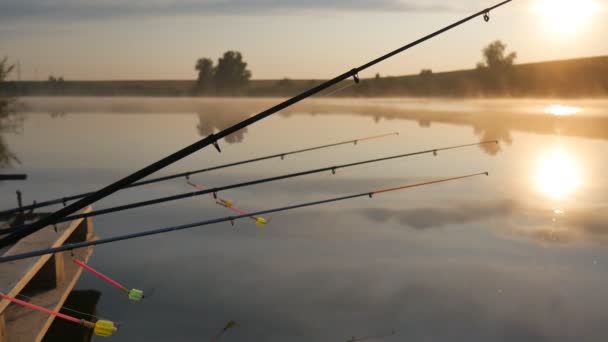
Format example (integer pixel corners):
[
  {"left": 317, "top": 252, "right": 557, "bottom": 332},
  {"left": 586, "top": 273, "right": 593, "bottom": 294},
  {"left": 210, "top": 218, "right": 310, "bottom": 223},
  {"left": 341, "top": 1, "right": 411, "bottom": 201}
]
[{"left": 27, "top": 98, "right": 608, "bottom": 155}]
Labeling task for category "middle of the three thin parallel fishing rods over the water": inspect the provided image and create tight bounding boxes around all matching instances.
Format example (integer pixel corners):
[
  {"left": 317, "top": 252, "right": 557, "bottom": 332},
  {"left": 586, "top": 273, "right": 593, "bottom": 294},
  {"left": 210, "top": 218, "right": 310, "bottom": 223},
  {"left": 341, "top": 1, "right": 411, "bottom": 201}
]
[{"left": 0, "top": 140, "right": 498, "bottom": 234}]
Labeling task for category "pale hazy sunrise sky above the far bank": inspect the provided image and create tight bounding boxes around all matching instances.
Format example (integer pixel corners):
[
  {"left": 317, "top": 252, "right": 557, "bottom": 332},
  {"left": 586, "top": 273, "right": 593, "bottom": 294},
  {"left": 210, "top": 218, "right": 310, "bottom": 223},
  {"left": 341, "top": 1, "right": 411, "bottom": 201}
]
[{"left": 0, "top": 0, "right": 608, "bottom": 80}]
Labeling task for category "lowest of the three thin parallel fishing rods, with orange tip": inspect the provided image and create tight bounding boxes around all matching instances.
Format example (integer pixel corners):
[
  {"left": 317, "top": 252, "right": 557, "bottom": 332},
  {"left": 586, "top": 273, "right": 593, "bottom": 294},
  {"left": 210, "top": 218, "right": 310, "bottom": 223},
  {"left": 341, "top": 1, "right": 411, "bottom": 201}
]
[{"left": 0, "top": 172, "right": 489, "bottom": 263}]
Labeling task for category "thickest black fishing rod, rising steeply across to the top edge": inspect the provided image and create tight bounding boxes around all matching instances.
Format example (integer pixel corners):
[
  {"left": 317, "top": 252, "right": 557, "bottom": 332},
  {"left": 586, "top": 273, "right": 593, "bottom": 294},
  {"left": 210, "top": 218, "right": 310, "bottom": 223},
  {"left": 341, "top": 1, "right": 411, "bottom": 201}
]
[{"left": 0, "top": 0, "right": 513, "bottom": 248}]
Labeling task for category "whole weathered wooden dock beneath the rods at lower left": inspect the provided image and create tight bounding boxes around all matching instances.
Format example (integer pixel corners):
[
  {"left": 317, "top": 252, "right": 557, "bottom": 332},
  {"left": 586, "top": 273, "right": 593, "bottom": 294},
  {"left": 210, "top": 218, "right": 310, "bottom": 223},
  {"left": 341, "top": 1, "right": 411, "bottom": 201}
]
[{"left": 0, "top": 207, "right": 95, "bottom": 342}]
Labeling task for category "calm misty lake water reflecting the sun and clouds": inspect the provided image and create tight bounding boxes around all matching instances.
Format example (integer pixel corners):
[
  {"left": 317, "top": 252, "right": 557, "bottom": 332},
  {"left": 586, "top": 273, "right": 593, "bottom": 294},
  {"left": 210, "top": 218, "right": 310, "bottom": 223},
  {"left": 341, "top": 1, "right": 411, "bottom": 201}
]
[{"left": 0, "top": 98, "right": 608, "bottom": 342}]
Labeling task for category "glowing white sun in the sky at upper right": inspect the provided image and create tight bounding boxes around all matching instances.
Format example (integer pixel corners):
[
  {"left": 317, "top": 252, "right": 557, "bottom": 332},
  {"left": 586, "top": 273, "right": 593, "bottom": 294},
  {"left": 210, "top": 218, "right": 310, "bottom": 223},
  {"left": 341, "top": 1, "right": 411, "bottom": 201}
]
[{"left": 534, "top": 0, "right": 599, "bottom": 34}]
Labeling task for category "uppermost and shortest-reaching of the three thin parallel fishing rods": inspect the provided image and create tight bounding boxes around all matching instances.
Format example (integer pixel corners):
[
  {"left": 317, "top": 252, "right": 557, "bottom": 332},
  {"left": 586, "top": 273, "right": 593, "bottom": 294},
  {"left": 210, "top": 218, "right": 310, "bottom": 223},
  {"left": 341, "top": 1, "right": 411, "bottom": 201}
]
[{"left": 0, "top": 132, "right": 399, "bottom": 217}]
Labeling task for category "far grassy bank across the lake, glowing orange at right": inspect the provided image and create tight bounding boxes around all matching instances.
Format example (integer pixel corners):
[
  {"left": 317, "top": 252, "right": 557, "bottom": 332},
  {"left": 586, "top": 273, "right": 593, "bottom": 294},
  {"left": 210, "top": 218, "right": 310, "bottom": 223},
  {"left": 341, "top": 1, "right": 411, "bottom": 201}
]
[{"left": 0, "top": 56, "right": 608, "bottom": 98}]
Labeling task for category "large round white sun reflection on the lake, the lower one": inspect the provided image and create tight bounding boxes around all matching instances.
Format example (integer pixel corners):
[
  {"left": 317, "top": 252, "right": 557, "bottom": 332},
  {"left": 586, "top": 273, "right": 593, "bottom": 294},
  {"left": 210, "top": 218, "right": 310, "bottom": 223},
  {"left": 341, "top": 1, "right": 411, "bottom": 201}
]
[{"left": 535, "top": 147, "right": 582, "bottom": 200}]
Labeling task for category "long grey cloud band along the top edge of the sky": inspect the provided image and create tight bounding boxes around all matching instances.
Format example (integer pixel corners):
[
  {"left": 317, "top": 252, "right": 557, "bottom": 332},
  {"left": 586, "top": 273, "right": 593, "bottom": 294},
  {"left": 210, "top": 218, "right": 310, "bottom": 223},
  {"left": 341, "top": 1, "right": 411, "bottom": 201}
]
[{"left": 0, "top": 0, "right": 452, "bottom": 19}]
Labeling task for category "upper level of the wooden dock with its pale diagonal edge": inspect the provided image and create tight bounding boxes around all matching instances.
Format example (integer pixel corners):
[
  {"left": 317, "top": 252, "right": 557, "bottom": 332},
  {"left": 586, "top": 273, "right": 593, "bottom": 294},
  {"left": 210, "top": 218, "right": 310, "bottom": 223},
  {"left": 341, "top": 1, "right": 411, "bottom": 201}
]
[{"left": 0, "top": 207, "right": 92, "bottom": 314}]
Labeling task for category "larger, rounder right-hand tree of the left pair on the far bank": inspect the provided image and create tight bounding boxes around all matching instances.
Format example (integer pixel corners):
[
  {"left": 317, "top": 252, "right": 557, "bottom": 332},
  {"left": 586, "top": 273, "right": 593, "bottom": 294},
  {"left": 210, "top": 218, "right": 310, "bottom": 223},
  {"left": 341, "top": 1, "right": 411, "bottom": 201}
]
[{"left": 213, "top": 51, "right": 251, "bottom": 92}]
